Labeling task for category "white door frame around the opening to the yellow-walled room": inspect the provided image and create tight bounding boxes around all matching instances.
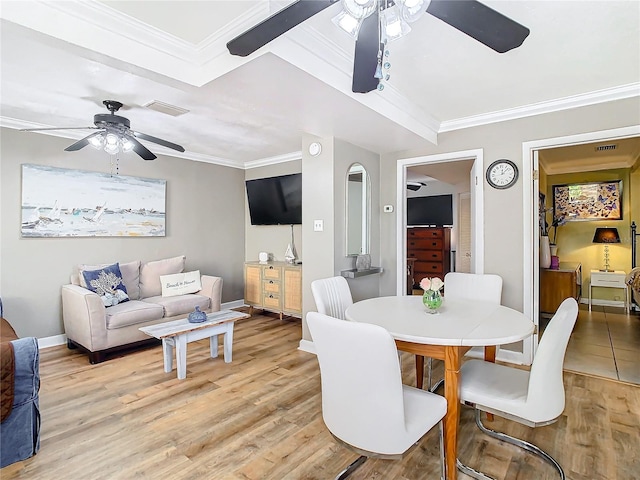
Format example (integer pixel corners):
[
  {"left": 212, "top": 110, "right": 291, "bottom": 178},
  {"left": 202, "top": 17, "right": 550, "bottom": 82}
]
[{"left": 522, "top": 125, "right": 640, "bottom": 364}]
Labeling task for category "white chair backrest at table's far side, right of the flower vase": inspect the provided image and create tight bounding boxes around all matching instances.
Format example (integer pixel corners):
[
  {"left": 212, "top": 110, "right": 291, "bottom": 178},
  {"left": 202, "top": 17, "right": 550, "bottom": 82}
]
[{"left": 444, "top": 272, "right": 502, "bottom": 304}]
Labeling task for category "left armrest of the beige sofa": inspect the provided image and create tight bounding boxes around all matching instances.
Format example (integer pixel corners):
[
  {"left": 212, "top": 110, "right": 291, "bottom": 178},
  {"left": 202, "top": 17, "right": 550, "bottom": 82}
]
[{"left": 62, "top": 285, "right": 107, "bottom": 352}]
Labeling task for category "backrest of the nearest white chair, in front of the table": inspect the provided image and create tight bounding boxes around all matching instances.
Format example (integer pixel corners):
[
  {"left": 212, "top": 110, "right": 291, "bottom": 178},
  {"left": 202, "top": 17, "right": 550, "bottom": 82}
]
[{"left": 307, "top": 312, "right": 406, "bottom": 453}]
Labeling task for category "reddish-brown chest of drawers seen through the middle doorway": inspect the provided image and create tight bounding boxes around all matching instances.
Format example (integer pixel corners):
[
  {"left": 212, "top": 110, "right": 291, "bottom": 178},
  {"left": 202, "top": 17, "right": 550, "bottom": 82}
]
[{"left": 407, "top": 227, "right": 451, "bottom": 285}]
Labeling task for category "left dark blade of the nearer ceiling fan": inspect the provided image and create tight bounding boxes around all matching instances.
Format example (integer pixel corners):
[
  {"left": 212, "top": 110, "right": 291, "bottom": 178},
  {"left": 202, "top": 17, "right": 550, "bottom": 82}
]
[{"left": 227, "top": 0, "right": 338, "bottom": 57}]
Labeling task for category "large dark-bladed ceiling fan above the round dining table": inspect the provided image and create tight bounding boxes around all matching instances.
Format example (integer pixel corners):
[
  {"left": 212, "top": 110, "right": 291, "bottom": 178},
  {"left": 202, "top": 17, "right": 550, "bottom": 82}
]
[{"left": 227, "top": 0, "right": 529, "bottom": 93}]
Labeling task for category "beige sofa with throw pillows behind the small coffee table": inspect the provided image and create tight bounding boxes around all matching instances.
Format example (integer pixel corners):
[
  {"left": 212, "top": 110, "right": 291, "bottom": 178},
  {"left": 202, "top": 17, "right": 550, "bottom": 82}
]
[{"left": 62, "top": 256, "right": 222, "bottom": 363}]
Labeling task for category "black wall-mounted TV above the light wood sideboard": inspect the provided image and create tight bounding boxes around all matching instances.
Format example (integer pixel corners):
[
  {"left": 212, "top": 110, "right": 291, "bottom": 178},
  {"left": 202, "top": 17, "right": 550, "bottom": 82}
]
[{"left": 245, "top": 173, "right": 302, "bottom": 225}]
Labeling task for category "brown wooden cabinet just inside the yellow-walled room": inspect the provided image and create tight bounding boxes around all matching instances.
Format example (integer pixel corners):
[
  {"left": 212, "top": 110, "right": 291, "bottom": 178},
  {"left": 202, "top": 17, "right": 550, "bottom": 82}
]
[{"left": 540, "top": 263, "right": 582, "bottom": 314}]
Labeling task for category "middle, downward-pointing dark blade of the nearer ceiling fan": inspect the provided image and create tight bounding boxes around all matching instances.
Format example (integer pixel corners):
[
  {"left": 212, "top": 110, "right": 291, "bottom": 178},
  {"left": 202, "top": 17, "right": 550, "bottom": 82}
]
[{"left": 351, "top": 10, "right": 382, "bottom": 93}]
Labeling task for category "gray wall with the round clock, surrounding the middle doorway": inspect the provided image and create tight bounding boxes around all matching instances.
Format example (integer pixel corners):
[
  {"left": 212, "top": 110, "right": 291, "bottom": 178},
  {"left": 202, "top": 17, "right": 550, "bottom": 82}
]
[{"left": 381, "top": 98, "right": 640, "bottom": 309}]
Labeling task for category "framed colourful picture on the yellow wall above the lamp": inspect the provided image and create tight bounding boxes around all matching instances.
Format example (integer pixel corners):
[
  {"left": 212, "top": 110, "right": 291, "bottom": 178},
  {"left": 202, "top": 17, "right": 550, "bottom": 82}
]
[{"left": 553, "top": 180, "right": 622, "bottom": 221}]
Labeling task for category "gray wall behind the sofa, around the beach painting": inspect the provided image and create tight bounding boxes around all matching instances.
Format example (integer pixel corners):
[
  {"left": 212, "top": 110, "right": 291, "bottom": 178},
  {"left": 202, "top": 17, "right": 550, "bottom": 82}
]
[{"left": 0, "top": 129, "right": 246, "bottom": 338}]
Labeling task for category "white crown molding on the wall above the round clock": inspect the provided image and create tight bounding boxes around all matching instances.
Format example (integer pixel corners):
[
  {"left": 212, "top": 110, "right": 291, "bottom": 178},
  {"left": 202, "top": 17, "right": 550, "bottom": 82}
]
[{"left": 438, "top": 83, "right": 640, "bottom": 133}]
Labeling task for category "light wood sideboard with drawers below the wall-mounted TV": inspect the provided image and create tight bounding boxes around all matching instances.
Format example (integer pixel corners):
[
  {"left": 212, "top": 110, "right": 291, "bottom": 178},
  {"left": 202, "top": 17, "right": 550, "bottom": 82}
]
[{"left": 244, "top": 262, "right": 302, "bottom": 320}]
